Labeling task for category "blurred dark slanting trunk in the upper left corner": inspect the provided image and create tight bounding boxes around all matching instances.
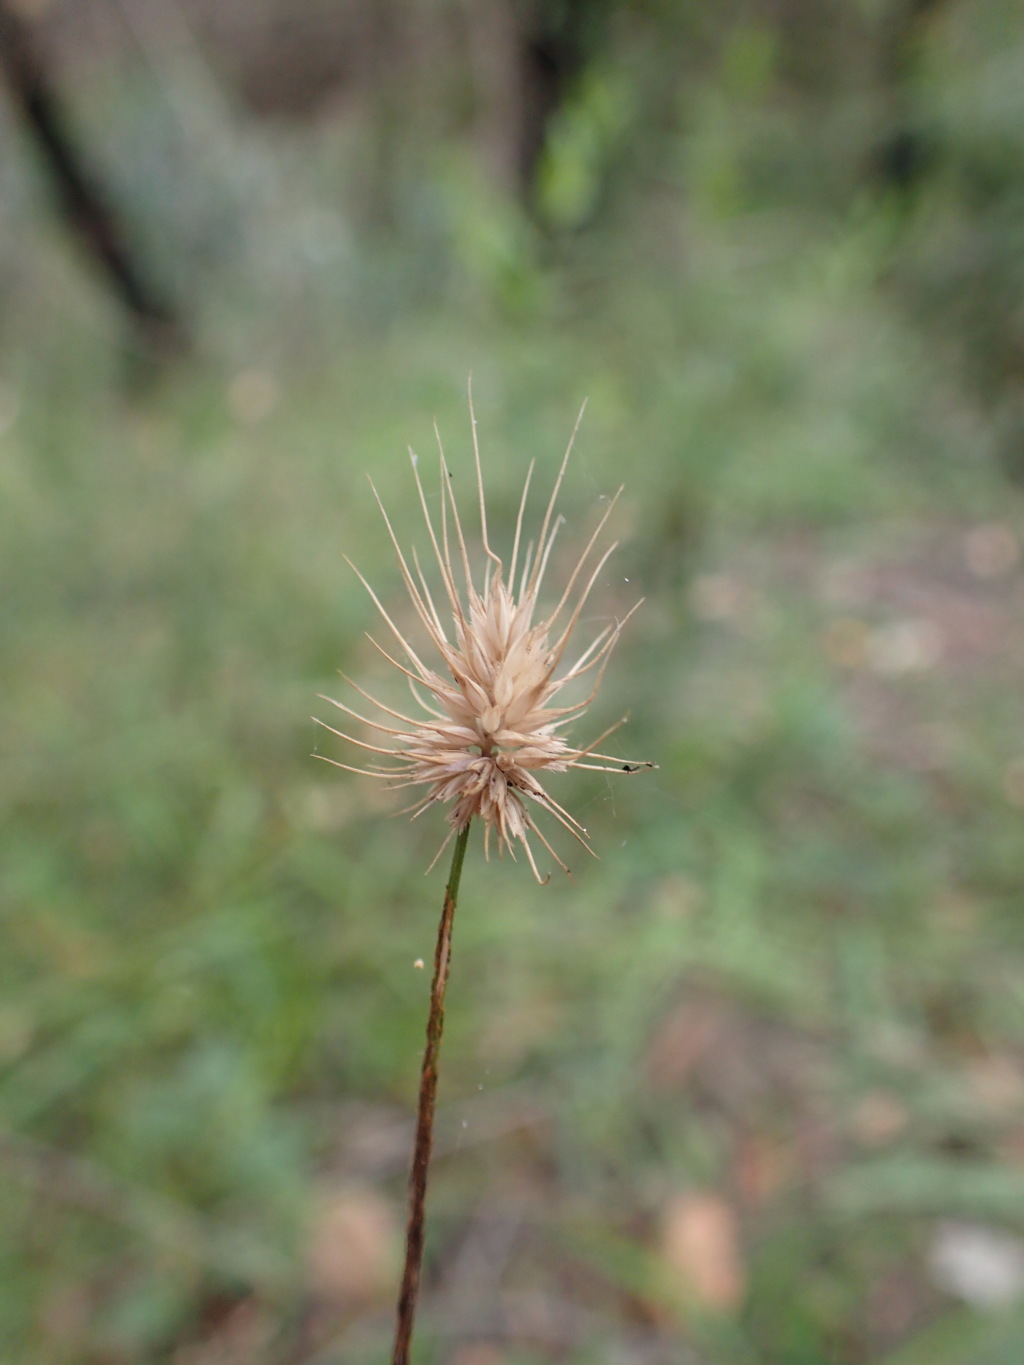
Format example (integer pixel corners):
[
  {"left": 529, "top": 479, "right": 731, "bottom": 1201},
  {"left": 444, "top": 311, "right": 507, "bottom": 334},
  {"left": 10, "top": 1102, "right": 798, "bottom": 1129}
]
[{"left": 0, "top": 0, "right": 186, "bottom": 355}]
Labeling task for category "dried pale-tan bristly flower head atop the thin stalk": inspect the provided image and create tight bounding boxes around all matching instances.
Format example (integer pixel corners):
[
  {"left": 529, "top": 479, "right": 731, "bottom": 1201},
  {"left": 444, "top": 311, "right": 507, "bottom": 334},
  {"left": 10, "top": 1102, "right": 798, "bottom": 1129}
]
[{"left": 318, "top": 399, "right": 655, "bottom": 882}]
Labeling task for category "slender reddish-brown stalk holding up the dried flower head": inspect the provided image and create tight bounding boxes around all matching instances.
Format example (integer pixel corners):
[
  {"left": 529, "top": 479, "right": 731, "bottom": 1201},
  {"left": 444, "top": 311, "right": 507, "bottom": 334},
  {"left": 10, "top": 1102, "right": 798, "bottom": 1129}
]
[{"left": 392, "top": 822, "right": 470, "bottom": 1365}]
